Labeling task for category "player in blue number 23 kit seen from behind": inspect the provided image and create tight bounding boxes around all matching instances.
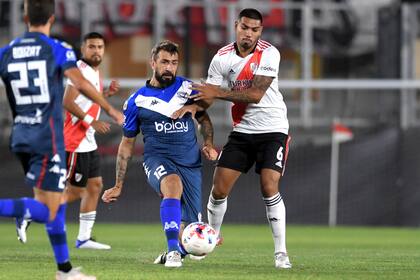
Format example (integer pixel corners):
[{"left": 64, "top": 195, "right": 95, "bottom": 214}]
[{"left": 0, "top": 0, "right": 123, "bottom": 279}]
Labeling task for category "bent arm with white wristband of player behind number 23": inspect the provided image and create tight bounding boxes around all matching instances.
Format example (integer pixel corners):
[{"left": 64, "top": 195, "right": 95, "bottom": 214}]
[{"left": 63, "top": 85, "right": 110, "bottom": 133}]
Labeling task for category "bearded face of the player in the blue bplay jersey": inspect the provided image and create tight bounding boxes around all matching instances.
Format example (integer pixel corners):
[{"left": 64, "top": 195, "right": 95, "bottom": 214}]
[{"left": 152, "top": 50, "right": 179, "bottom": 87}]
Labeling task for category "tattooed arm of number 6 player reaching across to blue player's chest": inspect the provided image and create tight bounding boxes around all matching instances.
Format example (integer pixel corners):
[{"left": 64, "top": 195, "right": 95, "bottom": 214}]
[{"left": 191, "top": 75, "right": 274, "bottom": 103}]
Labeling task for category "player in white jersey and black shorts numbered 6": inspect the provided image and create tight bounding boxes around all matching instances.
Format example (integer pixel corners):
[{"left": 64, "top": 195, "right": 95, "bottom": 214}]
[{"left": 185, "top": 9, "right": 292, "bottom": 268}]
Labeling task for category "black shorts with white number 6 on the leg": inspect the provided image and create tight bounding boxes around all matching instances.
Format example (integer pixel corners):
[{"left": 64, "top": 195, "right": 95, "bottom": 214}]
[{"left": 217, "top": 131, "right": 291, "bottom": 174}]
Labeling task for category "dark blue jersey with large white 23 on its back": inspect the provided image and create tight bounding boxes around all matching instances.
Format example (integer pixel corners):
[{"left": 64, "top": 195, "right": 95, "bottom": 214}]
[{"left": 0, "top": 32, "right": 77, "bottom": 154}]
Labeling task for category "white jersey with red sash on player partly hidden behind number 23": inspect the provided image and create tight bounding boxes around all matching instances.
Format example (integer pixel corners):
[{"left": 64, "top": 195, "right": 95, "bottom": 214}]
[{"left": 64, "top": 60, "right": 102, "bottom": 153}]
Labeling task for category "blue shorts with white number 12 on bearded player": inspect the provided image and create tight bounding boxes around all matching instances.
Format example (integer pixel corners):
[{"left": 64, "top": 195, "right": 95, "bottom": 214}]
[{"left": 143, "top": 156, "right": 201, "bottom": 223}]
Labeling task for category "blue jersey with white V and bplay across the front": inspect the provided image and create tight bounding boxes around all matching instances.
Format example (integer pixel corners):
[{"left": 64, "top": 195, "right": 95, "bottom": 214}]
[{"left": 123, "top": 77, "right": 201, "bottom": 167}]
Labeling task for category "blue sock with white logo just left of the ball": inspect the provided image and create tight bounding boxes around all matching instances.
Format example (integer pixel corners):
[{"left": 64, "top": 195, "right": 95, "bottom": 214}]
[{"left": 160, "top": 198, "right": 181, "bottom": 252}]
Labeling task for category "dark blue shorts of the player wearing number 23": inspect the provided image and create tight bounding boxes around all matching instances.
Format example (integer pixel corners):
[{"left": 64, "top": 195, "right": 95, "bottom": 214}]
[{"left": 16, "top": 151, "right": 66, "bottom": 192}]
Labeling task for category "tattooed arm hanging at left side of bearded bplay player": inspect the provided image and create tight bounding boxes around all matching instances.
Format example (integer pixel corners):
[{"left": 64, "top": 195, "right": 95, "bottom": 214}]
[{"left": 102, "top": 136, "right": 136, "bottom": 203}]
